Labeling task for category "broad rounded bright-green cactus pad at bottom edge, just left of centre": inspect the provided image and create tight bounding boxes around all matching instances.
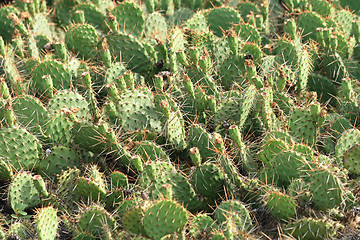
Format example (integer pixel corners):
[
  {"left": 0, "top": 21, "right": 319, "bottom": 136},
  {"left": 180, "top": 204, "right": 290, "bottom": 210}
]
[{"left": 143, "top": 200, "right": 188, "bottom": 240}]
